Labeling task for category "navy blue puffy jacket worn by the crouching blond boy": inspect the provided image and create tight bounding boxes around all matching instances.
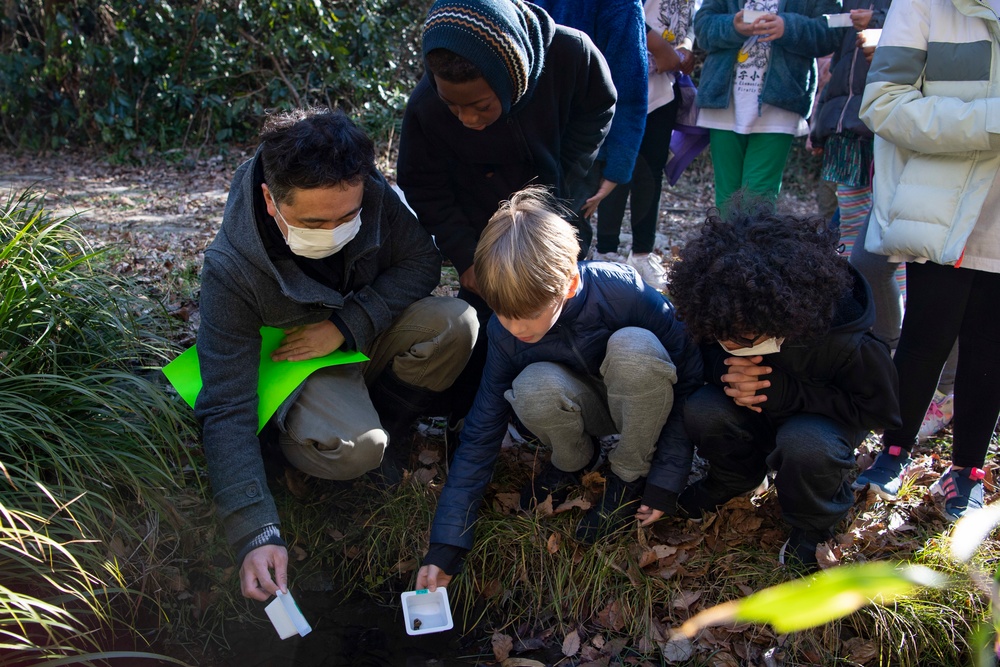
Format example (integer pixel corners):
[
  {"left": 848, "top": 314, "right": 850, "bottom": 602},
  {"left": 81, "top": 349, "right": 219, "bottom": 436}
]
[{"left": 424, "top": 262, "right": 703, "bottom": 574}]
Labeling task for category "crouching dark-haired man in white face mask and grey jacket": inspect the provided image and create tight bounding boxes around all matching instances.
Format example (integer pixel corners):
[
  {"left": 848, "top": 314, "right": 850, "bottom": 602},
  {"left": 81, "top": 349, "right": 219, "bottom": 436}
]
[{"left": 196, "top": 109, "right": 478, "bottom": 601}]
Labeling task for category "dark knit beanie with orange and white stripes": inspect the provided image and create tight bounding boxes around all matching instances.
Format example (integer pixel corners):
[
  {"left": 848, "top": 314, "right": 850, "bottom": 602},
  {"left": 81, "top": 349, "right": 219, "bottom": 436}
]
[{"left": 423, "top": 0, "right": 552, "bottom": 113}]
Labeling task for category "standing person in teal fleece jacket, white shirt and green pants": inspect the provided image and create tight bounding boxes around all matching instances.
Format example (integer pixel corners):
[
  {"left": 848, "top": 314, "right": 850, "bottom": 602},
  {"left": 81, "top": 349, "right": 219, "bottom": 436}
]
[{"left": 694, "top": 0, "right": 845, "bottom": 208}]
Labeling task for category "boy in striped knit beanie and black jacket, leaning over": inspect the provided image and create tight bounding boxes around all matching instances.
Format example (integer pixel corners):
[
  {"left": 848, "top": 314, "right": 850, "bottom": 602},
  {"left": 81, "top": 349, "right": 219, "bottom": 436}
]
[{"left": 397, "top": 0, "right": 616, "bottom": 430}]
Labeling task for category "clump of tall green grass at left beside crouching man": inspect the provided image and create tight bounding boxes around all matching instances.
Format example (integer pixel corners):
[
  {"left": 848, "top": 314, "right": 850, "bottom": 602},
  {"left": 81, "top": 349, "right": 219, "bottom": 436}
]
[{"left": 0, "top": 192, "right": 201, "bottom": 666}]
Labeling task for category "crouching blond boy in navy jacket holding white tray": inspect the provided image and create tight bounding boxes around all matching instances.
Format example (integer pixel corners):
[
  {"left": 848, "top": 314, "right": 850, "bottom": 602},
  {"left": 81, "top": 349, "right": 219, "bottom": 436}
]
[{"left": 417, "top": 188, "right": 702, "bottom": 590}]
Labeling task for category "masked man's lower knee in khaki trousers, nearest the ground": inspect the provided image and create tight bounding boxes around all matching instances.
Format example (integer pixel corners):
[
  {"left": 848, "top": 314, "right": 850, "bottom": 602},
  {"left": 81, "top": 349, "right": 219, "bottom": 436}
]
[{"left": 278, "top": 428, "right": 388, "bottom": 480}]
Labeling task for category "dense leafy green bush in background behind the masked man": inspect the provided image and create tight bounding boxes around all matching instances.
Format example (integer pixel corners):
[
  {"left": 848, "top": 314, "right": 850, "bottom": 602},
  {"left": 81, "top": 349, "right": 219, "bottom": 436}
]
[{"left": 0, "top": 0, "right": 430, "bottom": 157}]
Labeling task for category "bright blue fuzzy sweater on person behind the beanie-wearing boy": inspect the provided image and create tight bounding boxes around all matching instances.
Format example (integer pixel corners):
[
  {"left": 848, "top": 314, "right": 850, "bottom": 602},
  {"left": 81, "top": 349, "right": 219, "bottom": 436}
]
[{"left": 535, "top": 0, "right": 648, "bottom": 183}]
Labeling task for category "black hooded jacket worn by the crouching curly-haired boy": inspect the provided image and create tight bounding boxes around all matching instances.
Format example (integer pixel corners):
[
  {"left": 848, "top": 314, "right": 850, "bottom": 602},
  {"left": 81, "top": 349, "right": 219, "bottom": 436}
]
[{"left": 702, "top": 266, "right": 902, "bottom": 431}]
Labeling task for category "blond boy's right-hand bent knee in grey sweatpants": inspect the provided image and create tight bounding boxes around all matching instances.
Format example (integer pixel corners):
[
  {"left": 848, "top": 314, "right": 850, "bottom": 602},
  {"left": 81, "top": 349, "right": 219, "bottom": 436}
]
[{"left": 601, "top": 327, "right": 677, "bottom": 393}]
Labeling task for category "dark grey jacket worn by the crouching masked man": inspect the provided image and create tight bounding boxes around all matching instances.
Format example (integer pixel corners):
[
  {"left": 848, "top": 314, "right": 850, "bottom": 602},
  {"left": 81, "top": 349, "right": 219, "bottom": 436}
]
[{"left": 195, "top": 151, "right": 441, "bottom": 545}]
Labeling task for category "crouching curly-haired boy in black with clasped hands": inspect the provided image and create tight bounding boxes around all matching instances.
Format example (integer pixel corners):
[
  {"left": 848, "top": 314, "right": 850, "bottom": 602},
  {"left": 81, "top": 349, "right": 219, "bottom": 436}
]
[{"left": 670, "top": 193, "right": 900, "bottom": 570}]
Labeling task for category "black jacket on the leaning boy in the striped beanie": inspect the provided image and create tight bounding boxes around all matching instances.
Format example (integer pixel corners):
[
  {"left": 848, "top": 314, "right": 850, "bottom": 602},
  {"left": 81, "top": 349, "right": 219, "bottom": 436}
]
[{"left": 397, "top": 20, "right": 616, "bottom": 274}]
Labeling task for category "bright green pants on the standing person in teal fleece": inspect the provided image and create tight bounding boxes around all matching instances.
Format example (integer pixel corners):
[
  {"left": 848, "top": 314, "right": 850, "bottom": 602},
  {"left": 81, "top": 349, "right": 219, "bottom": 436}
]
[{"left": 708, "top": 129, "right": 793, "bottom": 209}]
